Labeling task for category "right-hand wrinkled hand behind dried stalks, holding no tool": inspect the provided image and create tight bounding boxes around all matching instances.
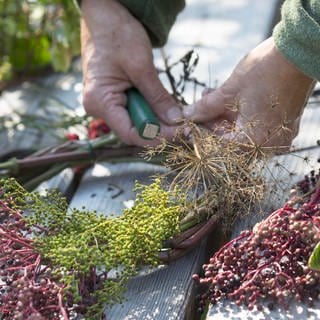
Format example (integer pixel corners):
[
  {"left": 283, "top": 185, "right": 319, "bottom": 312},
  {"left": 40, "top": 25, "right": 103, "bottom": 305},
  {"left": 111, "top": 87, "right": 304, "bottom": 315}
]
[{"left": 184, "top": 38, "right": 314, "bottom": 151}]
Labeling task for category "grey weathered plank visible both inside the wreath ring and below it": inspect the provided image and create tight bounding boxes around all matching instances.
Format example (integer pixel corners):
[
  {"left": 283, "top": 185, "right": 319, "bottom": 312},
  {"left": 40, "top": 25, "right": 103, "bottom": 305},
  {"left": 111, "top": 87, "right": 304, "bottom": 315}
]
[{"left": 70, "top": 163, "right": 208, "bottom": 320}]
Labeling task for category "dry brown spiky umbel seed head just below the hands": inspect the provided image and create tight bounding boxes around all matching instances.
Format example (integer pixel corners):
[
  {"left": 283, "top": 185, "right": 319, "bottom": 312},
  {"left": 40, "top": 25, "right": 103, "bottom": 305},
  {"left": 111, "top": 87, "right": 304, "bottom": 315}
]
[{"left": 146, "top": 124, "right": 265, "bottom": 228}]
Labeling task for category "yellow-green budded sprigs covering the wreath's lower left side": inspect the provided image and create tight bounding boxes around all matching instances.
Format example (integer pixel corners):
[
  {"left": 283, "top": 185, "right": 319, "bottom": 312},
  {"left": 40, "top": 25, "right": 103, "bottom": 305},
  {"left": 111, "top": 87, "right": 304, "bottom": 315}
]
[{"left": 0, "top": 178, "right": 185, "bottom": 319}]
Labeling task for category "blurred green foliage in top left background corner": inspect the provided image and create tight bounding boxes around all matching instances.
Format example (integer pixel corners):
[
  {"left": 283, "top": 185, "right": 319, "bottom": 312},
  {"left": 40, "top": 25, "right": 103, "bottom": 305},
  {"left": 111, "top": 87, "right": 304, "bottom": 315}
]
[{"left": 0, "top": 0, "right": 80, "bottom": 81}]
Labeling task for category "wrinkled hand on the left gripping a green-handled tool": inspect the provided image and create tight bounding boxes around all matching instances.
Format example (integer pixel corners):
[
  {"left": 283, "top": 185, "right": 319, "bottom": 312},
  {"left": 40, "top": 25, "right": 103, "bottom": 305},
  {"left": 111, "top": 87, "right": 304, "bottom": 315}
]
[{"left": 81, "top": 0, "right": 182, "bottom": 146}]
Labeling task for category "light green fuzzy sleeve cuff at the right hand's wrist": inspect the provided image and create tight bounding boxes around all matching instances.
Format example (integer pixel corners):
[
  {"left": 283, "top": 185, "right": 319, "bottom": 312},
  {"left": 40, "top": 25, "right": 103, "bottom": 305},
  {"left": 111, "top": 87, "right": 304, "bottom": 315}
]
[{"left": 273, "top": 0, "right": 320, "bottom": 80}]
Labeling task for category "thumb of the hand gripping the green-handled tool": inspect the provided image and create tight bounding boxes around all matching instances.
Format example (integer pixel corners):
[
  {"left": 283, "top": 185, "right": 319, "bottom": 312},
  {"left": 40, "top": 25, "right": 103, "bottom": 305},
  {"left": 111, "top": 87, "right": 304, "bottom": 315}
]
[{"left": 133, "top": 67, "right": 183, "bottom": 125}]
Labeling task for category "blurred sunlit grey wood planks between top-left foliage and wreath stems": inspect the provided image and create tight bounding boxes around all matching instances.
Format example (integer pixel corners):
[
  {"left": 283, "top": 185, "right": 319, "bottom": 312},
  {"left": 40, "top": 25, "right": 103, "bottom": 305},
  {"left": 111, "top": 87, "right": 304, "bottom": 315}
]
[{"left": 0, "top": 72, "right": 84, "bottom": 155}]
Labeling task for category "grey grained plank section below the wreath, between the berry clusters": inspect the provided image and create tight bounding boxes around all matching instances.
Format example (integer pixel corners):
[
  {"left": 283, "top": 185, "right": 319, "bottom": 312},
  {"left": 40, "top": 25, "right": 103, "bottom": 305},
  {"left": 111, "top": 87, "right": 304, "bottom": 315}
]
[{"left": 106, "top": 247, "right": 204, "bottom": 320}]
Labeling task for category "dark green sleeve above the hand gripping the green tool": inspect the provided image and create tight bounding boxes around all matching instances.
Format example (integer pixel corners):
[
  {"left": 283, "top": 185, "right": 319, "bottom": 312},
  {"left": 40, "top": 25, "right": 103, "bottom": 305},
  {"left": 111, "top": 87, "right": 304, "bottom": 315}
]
[{"left": 76, "top": 0, "right": 185, "bottom": 47}]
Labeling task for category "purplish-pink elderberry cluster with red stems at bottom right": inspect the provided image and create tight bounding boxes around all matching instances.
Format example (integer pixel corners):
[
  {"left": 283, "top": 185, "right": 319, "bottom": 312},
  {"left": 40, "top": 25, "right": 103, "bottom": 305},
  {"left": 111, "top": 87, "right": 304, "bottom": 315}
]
[{"left": 193, "top": 172, "right": 320, "bottom": 310}]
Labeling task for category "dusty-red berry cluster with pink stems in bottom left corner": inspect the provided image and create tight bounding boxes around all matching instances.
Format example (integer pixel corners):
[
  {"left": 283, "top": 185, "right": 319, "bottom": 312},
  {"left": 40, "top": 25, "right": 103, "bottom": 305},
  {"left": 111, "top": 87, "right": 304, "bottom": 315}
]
[{"left": 0, "top": 201, "right": 69, "bottom": 320}]
